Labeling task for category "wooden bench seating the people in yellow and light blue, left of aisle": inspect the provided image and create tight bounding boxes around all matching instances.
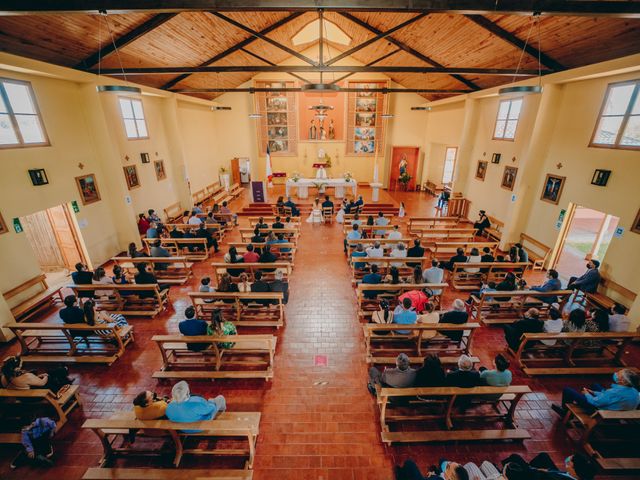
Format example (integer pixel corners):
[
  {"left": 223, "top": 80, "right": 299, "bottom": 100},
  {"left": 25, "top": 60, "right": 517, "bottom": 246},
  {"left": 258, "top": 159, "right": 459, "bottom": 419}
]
[{"left": 82, "top": 412, "right": 261, "bottom": 469}]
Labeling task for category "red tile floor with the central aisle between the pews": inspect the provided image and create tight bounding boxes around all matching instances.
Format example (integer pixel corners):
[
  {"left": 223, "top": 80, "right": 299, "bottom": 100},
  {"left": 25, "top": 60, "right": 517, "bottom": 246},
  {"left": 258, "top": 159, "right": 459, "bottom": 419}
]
[{"left": 0, "top": 187, "right": 637, "bottom": 480}]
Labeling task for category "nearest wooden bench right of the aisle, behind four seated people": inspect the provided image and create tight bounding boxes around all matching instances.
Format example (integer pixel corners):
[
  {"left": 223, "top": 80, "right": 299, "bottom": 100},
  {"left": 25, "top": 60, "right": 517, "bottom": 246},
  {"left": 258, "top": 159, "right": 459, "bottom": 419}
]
[{"left": 378, "top": 385, "right": 531, "bottom": 445}]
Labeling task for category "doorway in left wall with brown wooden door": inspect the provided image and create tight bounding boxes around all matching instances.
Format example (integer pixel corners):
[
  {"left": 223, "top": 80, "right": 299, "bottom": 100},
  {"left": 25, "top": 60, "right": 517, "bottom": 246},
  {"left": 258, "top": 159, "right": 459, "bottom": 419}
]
[{"left": 20, "top": 205, "right": 87, "bottom": 285}]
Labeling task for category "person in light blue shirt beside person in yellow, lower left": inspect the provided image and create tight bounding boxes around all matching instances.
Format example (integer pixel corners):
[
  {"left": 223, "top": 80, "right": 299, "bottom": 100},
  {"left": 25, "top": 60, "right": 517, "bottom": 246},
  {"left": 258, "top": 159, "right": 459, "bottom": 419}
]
[{"left": 166, "top": 380, "right": 227, "bottom": 433}]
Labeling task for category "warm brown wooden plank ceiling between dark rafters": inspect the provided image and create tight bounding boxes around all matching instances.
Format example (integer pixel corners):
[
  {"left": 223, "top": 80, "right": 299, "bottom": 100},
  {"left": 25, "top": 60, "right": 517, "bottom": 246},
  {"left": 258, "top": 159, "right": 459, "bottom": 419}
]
[{"left": 0, "top": 11, "right": 640, "bottom": 99}]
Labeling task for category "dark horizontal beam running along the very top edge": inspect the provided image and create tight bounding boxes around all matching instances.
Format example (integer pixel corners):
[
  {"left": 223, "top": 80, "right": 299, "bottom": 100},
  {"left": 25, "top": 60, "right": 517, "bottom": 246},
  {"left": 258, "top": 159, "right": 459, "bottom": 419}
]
[{"left": 0, "top": 0, "right": 640, "bottom": 18}]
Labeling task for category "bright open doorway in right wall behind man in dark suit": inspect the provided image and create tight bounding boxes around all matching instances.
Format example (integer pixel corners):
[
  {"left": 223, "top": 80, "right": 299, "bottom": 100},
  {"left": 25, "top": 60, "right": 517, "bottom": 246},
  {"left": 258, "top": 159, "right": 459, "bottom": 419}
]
[{"left": 554, "top": 205, "right": 620, "bottom": 281}]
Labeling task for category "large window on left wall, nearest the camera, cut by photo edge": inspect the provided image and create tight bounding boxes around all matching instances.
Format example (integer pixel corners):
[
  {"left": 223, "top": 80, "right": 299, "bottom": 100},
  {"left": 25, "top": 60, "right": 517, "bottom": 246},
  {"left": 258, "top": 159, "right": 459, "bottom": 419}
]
[{"left": 0, "top": 78, "right": 49, "bottom": 147}]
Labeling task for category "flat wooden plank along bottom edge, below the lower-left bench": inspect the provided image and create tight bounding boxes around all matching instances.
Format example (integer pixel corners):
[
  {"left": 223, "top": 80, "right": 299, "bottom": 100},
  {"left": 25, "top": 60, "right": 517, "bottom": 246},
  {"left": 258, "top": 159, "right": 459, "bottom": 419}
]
[{"left": 82, "top": 467, "right": 253, "bottom": 480}]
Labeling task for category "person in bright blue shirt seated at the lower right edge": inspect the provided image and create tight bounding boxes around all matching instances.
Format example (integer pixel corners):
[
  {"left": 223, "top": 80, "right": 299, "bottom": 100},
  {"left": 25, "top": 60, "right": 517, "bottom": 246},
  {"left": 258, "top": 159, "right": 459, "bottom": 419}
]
[{"left": 551, "top": 368, "right": 640, "bottom": 417}]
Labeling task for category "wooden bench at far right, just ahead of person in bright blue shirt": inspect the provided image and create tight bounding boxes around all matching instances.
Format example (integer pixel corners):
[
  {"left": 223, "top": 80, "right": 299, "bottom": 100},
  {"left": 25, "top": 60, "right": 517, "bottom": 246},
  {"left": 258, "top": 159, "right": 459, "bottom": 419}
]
[{"left": 509, "top": 332, "right": 640, "bottom": 375}]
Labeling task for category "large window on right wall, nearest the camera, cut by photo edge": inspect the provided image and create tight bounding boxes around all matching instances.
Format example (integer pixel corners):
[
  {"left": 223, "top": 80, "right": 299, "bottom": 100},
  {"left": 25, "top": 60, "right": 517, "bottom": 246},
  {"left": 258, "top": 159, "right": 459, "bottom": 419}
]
[{"left": 591, "top": 80, "right": 640, "bottom": 149}]
